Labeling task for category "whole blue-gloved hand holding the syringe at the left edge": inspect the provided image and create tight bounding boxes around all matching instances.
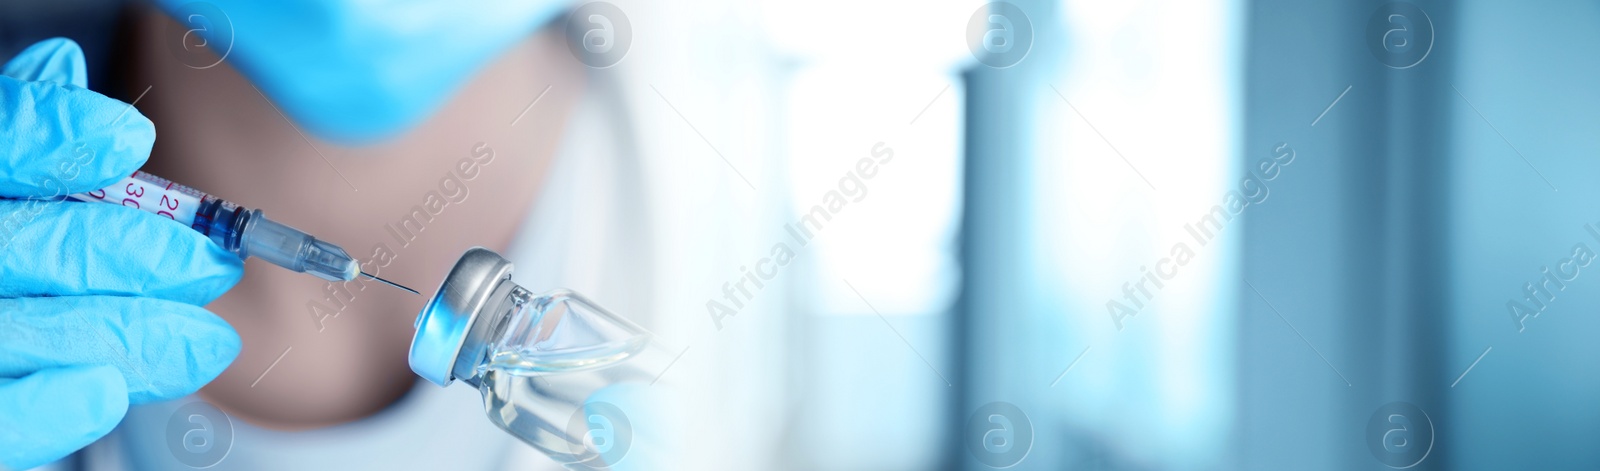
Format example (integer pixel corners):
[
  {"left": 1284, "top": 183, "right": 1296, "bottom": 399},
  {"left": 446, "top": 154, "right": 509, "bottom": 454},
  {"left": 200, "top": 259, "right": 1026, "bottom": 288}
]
[{"left": 0, "top": 38, "right": 242, "bottom": 469}]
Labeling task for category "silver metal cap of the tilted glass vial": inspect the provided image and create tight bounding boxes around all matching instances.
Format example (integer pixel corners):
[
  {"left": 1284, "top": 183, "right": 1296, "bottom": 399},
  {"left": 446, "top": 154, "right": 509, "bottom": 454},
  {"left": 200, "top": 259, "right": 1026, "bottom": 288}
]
[{"left": 410, "top": 247, "right": 512, "bottom": 386}]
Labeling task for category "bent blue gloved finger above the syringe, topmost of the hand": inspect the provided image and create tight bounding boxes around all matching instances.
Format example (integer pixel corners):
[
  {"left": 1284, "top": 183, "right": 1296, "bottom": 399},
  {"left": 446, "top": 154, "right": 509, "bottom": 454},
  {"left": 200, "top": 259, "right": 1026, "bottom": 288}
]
[{"left": 0, "top": 38, "right": 155, "bottom": 197}]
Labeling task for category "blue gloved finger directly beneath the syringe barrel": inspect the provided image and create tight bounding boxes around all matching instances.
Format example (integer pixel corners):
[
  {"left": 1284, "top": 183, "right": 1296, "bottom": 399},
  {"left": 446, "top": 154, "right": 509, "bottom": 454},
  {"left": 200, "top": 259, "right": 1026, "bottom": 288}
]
[{"left": 0, "top": 200, "right": 243, "bottom": 304}]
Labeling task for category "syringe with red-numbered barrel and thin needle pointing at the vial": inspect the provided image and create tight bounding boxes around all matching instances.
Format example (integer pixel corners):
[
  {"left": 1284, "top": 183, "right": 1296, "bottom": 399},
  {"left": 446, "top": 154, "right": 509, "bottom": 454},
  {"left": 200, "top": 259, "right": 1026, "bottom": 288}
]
[{"left": 69, "top": 171, "right": 418, "bottom": 295}]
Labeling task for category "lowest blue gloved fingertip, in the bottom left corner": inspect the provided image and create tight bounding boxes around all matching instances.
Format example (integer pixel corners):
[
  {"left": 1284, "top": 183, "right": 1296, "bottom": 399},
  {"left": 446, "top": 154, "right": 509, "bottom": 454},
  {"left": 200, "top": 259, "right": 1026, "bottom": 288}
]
[{"left": 0, "top": 365, "right": 128, "bottom": 469}]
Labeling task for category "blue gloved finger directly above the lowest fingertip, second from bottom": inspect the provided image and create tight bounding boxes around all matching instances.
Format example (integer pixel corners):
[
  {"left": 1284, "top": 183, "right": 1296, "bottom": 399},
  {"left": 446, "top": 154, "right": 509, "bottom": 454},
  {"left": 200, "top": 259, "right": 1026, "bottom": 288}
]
[{"left": 0, "top": 296, "right": 240, "bottom": 404}]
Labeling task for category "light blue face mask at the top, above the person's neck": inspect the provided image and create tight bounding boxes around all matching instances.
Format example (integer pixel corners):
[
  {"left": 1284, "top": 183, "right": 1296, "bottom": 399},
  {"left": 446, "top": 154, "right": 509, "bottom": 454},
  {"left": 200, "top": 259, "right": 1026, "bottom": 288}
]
[{"left": 157, "top": 0, "right": 566, "bottom": 144}]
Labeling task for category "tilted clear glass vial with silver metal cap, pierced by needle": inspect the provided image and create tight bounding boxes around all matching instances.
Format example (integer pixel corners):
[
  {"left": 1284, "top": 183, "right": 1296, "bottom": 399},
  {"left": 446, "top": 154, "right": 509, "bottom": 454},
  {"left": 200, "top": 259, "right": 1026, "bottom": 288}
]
[{"left": 410, "top": 247, "right": 650, "bottom": 468}]
